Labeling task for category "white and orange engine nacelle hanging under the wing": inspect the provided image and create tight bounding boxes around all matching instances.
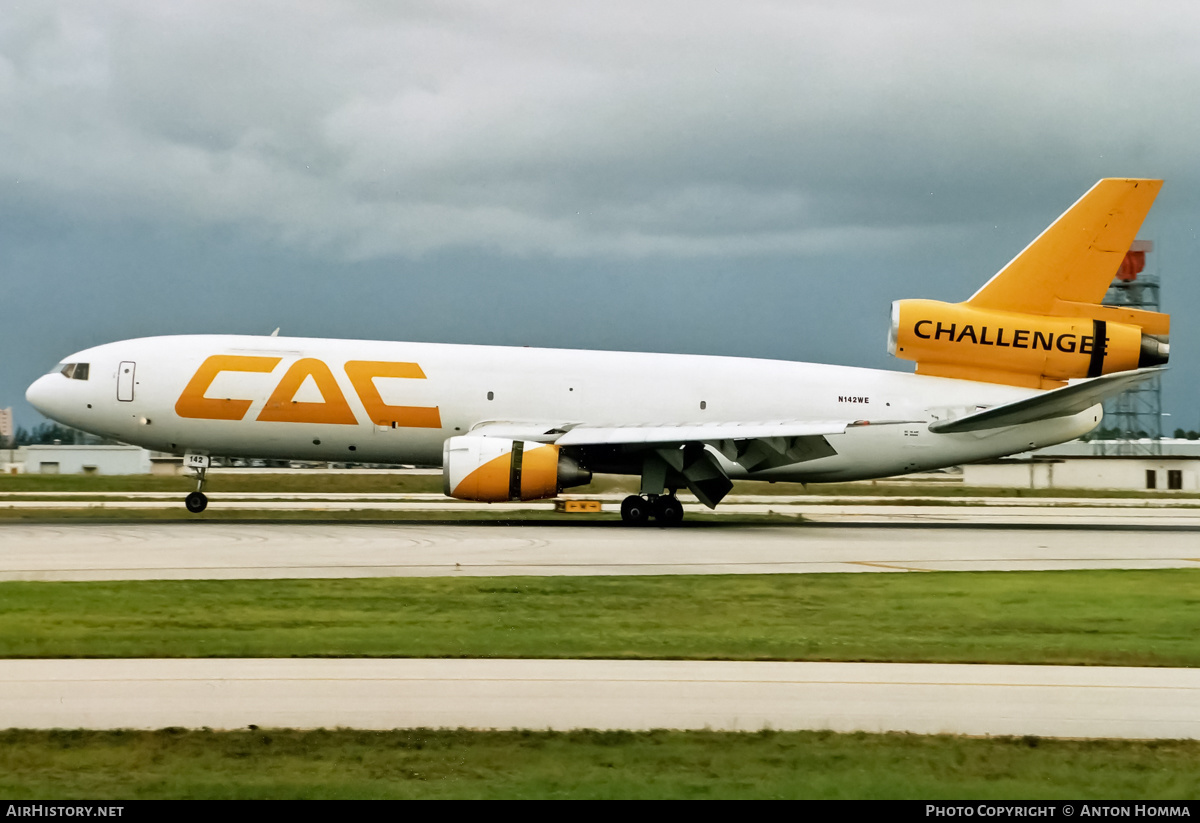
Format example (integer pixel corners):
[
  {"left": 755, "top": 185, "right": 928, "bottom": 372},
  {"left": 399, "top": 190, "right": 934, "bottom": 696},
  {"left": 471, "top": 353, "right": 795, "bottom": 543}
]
[{"left": 442, "top": 434, "right": 592, "bottom": 503}]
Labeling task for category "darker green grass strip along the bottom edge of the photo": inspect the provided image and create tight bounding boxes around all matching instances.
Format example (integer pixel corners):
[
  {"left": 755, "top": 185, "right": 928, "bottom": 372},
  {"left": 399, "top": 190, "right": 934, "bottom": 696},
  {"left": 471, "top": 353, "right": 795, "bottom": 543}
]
[{"left": 0, "top": 729, "right": 1200, "bottom": 800}]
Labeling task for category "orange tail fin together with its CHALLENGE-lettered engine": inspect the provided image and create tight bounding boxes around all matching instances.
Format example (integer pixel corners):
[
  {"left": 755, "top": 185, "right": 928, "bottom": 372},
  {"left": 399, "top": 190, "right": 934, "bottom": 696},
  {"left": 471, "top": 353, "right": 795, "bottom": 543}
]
[{"left": 888, "top": 178, "right": 1171, "bottom": 389}]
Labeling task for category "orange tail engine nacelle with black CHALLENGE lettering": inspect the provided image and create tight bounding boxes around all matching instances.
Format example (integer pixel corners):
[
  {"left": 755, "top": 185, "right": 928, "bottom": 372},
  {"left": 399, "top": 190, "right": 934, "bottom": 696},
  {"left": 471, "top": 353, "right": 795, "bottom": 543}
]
[{"left": 888, "top": 300, "right": 1169, "bottom": 389}]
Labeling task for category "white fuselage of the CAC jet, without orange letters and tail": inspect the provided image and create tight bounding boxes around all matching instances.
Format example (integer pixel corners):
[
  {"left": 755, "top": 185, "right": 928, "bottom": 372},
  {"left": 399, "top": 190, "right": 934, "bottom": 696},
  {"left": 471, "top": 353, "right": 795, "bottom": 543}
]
[{"left": 26, "top": 335, "right": 1100, "bottom": 481}]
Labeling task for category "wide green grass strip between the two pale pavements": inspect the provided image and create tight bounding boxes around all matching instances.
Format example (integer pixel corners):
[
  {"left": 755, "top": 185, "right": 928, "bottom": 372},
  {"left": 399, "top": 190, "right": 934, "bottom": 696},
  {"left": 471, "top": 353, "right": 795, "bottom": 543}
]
[{"left": 0, "top": 570, "right": 1200, "bottom": 666}]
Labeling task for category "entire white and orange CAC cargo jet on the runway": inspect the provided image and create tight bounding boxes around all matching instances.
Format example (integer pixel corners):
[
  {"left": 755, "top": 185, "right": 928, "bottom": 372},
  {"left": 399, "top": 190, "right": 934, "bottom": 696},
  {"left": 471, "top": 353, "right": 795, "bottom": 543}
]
[{"left": 26, "top": 179, "right": 1170, "bottom": 524}]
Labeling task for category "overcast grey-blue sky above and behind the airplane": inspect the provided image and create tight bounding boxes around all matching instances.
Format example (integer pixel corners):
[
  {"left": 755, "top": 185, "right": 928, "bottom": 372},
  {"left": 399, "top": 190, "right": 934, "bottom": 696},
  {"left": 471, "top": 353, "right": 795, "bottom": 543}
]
[{"left": 0, "top": 0, "right": 1200, "bottom": 429}]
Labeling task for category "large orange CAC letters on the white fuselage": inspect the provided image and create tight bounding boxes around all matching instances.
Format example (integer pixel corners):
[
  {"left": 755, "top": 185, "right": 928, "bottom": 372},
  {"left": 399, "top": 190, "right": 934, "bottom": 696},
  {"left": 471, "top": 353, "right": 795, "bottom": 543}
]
[{"left": 175, "top": 354, "right": 442, "bottom": 428}]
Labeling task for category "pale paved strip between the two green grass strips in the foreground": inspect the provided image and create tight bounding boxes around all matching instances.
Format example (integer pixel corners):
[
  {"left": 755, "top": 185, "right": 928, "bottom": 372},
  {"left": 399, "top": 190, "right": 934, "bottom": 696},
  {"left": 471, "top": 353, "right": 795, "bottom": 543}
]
[{"left": 0, "top": 660, "right": 1200, "bottom": 739}]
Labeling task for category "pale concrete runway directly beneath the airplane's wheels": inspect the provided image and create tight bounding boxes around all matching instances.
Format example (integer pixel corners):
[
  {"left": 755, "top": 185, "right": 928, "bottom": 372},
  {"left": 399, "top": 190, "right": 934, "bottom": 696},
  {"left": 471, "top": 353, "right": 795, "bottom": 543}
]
[{"left": 0, "top": 518, "right": 1200, "bottom": 581}]
